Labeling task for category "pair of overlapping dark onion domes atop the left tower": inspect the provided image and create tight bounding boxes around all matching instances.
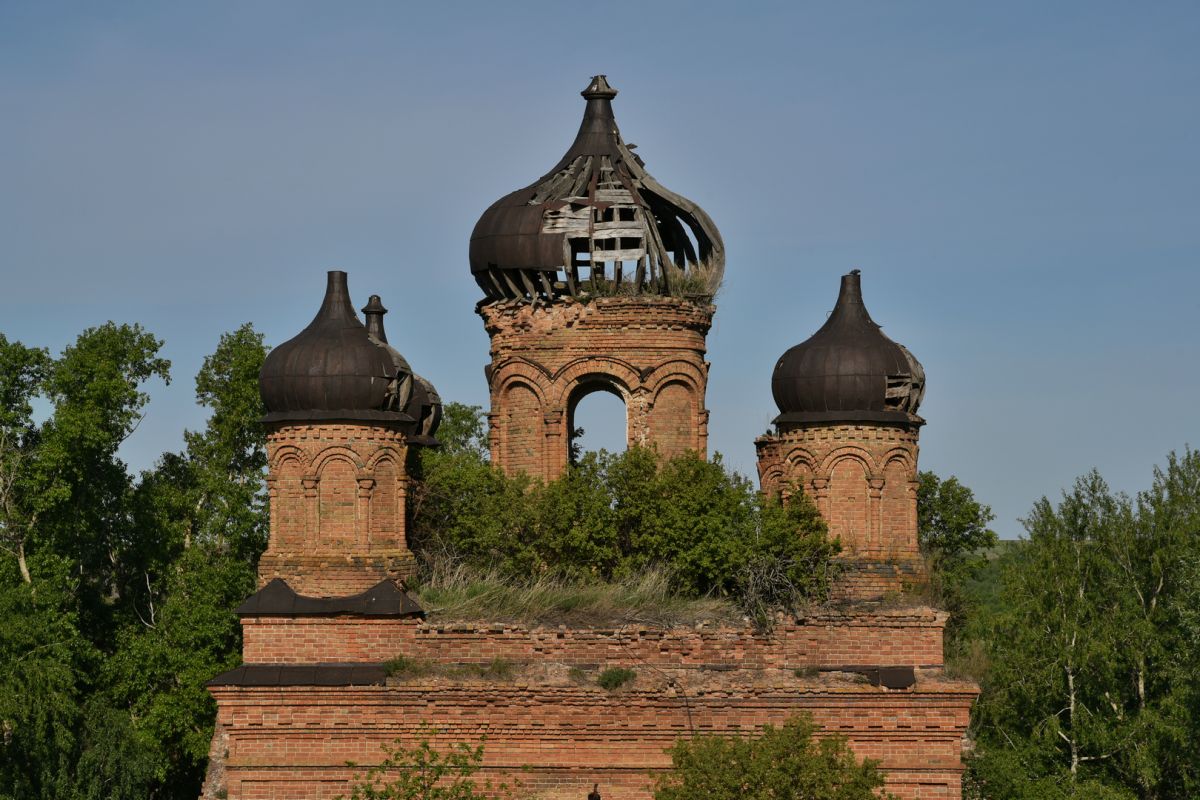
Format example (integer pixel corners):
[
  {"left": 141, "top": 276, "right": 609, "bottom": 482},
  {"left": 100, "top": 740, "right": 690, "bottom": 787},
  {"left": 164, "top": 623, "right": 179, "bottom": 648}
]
[{"left": 258, "top": 271, "right": 442, "bottom": 444}]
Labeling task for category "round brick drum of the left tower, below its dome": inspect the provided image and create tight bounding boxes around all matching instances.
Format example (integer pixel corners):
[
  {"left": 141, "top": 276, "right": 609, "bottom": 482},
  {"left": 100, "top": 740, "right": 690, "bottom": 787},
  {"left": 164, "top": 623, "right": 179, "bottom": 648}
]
[{"left": 258, "top": 422, "right": 414, "bottom": 597}]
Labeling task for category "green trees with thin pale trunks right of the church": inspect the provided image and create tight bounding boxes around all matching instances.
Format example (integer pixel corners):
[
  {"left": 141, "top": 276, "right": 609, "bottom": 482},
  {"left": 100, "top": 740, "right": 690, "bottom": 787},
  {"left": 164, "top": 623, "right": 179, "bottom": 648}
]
[{"left": 970, "top": 451, "right": 1200, "bottom": 800}]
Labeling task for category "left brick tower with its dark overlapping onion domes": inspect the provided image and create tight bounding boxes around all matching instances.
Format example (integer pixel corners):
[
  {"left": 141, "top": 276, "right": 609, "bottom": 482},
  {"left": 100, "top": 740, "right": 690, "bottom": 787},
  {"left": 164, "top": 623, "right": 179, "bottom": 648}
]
[{"left": 259, "top": 272, "right": 440, "bottom": 597}]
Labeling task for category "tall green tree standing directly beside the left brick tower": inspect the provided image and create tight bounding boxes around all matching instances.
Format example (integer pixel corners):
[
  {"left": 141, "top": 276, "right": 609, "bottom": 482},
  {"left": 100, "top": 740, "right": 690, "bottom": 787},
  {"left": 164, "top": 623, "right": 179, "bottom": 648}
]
[{"left": 101, "top": 325, "right": 268, "bottom": 799}]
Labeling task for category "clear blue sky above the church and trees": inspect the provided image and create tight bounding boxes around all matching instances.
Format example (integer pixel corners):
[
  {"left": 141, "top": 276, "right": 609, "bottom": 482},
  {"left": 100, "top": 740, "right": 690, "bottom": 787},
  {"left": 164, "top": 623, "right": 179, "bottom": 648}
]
[{"left": 0, "top": 0, "right": 1200, "bottom": 536}]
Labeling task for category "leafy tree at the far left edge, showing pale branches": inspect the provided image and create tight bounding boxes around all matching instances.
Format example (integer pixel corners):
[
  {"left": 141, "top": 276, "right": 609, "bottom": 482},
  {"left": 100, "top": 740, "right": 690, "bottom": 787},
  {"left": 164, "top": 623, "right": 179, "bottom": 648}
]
[{"left": 0, "top": 323, "right": 169, "bottom": 798}]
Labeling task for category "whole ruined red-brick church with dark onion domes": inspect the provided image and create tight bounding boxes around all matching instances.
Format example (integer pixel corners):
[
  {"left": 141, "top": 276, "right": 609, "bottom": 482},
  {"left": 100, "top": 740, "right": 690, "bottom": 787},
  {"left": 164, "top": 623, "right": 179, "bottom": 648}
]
[{"left": 204, "top": 76, "right": 978, "bottom": 800}]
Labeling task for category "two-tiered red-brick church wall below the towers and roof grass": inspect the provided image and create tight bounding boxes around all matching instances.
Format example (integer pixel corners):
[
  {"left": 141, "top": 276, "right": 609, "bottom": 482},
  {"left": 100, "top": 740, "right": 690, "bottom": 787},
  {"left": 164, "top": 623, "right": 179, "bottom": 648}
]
[{"left": 214, "top": 608, "right": 977, "bottom": 800}]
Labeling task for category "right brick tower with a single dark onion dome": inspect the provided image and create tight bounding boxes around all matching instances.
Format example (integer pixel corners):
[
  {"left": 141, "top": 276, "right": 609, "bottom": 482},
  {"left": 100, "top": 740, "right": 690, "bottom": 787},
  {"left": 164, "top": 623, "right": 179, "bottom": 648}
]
[{"left": 755, "top": 270, "right": 925, "bottom": 599}]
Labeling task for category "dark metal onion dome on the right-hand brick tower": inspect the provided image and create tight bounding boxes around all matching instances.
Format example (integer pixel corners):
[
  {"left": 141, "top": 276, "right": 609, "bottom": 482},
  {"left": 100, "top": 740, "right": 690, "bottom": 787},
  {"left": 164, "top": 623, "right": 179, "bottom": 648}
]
[{"left": 770, "top": 270, "right": 925, "bottom": 426}]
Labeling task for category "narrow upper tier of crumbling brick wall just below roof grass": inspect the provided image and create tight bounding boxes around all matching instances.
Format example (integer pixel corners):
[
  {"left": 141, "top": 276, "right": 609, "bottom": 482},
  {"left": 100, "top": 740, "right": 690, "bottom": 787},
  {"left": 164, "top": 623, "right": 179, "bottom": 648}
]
[{"left": 241, "top": 608, "right": 946, "bottom": 669}]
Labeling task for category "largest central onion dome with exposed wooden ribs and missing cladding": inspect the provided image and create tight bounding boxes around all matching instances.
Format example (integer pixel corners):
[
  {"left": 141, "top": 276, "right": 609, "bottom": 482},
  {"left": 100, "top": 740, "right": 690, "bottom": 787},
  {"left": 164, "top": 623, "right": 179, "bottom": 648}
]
[{"left": 470, "top": 76, "right": 725, "bottom": 302}]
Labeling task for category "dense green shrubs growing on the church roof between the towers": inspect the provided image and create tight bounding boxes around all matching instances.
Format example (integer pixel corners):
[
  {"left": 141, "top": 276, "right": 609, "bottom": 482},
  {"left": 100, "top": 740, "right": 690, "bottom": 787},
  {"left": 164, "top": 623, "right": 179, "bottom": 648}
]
[{"left": 409, "top": 404, "right": 836, "bottom": 618}]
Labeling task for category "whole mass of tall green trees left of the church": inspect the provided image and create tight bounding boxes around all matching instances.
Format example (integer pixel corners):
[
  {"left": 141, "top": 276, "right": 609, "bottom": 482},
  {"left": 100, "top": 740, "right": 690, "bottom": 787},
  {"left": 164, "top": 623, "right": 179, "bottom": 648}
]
[{"left": 0, "top": 323, "right": 265, "bottom": 800}]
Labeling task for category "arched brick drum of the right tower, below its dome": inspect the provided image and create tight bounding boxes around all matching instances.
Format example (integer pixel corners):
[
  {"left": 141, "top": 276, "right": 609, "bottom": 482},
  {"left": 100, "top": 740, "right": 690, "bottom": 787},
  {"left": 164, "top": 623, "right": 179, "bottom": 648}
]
[{"left": 755, "top": 422, "right": 923, "bottom": 599}]
